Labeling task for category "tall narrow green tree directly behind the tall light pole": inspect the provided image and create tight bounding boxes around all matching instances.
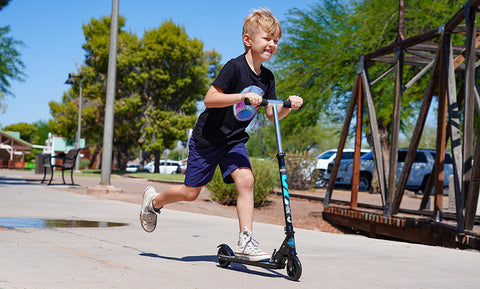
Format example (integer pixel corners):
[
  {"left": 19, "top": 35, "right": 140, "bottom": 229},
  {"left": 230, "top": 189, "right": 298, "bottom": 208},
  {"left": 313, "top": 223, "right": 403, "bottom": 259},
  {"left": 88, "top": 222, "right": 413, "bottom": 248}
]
[{"left": 82, "top": 17, "right": 146, "bottom": 169}]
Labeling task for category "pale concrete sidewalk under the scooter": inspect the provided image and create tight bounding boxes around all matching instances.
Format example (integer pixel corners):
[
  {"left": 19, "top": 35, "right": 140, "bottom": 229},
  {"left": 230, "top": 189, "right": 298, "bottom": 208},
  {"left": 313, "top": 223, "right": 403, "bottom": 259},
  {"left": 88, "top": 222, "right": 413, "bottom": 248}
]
[{"left": 0, "top": 170, "right": 480, "bottom": 288}]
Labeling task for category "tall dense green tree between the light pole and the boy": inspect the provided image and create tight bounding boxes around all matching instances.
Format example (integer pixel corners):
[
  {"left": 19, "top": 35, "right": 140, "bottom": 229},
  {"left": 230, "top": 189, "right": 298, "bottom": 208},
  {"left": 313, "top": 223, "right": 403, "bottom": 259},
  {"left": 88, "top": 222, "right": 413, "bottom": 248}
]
[{"left": 135, "top": 20, "right": 210, "bottom": 171}]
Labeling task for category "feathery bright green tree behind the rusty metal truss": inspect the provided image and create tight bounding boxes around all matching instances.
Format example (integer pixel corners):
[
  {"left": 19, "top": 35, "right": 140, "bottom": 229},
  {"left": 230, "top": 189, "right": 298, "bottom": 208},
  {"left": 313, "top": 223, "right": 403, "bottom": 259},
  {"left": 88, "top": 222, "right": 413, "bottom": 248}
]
[{"left": 275, "top": 0, "right": 464, "bottom": 153}]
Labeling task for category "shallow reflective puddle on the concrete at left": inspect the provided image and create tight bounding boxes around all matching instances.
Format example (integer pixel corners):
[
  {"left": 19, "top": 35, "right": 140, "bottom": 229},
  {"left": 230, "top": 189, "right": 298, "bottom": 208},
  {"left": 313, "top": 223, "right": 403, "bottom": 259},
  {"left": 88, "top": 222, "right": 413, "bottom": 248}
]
[{"left": 0, "top": 218, "right": 128, "bottom": 228}]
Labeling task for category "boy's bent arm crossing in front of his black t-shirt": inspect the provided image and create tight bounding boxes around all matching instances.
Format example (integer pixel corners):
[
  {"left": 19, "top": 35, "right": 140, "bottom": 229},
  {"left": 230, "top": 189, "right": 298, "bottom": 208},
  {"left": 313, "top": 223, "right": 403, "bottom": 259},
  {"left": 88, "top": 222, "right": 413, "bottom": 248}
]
[{"left": 203, "top": 85, "right": 262, "bottom": 108}]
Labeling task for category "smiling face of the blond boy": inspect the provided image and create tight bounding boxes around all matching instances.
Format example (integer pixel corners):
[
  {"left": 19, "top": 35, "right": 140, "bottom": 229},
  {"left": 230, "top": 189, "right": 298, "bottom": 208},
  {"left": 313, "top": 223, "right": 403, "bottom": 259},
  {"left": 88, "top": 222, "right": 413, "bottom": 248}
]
[{"left": 244, "top": 29, "right": 278, "bottom": 61}]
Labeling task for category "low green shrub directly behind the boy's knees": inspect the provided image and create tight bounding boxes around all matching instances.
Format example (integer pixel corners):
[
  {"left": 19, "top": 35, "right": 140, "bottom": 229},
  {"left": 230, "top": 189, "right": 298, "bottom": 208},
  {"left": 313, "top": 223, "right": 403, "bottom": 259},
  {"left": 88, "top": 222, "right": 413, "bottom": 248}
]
[{"left": 207, "top": 159, "right": 279, "bottom": 207}]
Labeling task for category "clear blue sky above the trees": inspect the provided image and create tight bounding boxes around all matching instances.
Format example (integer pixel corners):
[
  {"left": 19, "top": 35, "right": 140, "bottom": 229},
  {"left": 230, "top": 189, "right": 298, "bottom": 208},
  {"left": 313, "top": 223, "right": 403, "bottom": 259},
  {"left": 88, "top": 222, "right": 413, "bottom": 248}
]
[{"left": 0, "top": 0, "right": 321, "bottom": 128}]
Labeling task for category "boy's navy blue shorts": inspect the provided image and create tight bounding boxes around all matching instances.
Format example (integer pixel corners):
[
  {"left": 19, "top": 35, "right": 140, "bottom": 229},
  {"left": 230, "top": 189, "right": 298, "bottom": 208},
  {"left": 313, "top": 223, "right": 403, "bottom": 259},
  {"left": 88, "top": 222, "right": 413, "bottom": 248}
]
[{"left": 184, "top": 138, "right": 252, "bottom": 187}]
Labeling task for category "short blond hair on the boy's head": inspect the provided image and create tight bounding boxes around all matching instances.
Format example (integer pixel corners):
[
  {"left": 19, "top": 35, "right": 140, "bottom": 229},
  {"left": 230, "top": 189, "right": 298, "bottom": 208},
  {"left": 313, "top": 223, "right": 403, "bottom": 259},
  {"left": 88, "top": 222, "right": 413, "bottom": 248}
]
[{"left": 242, "top": 8, "right": 282, "bottom": 39}]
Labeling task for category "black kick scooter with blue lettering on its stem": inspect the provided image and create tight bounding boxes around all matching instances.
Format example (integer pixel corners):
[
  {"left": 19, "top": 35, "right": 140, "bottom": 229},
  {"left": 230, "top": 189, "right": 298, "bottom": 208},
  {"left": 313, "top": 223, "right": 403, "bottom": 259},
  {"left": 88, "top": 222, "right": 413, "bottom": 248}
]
[{"left": 217, "top": 99, "right": 302, "bottom": 281}]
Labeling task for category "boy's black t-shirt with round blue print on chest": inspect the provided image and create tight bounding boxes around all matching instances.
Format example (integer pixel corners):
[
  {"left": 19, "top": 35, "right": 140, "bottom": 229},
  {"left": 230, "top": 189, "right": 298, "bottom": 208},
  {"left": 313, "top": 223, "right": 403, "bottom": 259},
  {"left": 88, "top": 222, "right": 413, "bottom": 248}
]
[{"left": 193, "top": 55, "right": 277, "bottom": 146}]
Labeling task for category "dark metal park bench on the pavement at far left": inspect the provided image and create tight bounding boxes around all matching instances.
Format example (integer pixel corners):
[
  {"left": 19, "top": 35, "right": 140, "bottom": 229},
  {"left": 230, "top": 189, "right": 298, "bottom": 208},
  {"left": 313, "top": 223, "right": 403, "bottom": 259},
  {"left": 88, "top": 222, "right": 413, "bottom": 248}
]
[{"left": 42, "top": 149, "right": 80, "bottom": 185}]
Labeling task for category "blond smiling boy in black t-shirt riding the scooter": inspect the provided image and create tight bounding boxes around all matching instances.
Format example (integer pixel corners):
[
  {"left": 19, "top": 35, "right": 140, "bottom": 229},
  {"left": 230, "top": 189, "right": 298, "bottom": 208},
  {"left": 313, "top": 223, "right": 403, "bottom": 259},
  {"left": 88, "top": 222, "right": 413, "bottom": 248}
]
[{"left": 140, "top": 9, "right": 303, "bottom": 261}]
